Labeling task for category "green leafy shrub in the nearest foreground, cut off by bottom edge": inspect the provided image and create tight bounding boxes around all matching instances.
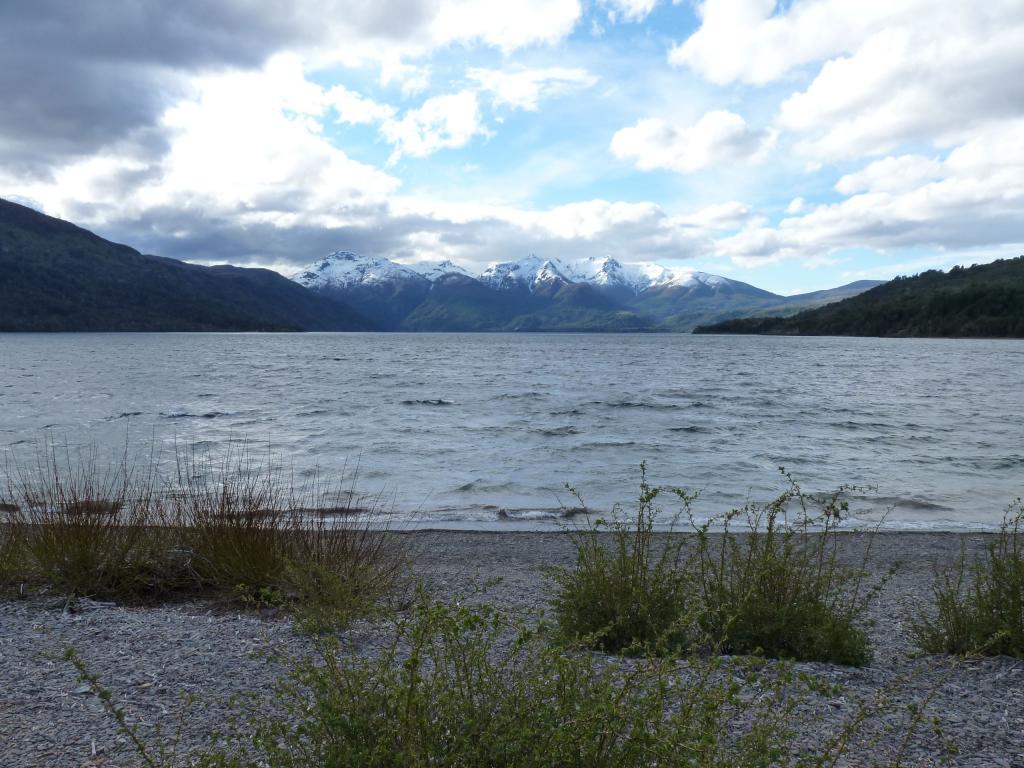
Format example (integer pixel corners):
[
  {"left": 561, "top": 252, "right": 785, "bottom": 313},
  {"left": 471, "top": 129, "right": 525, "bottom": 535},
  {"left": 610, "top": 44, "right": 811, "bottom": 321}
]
[{"left": 201, "top": 599, "right": 825, "bottom": 768}]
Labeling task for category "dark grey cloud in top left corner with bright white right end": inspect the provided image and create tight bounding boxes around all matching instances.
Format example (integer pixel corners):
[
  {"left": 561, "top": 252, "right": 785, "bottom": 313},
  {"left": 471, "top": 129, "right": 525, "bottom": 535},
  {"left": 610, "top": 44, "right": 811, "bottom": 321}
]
[{"left": 0, "top": 0, "right": 581, "bottom": 178}]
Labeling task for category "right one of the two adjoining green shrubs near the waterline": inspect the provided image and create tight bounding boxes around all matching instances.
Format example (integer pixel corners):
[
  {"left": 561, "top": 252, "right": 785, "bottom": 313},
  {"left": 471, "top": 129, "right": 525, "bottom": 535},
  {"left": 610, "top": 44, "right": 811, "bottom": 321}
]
[{"left": 695, "top": 470, "right": 894, "bottom": 666}]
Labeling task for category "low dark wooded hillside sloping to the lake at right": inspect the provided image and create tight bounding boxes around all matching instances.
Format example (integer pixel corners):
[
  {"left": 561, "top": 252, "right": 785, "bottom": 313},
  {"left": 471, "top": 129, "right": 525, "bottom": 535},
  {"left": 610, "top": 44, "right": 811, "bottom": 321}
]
[{"left": 694, "top": 256, "right": 1024, "bottom": 338}]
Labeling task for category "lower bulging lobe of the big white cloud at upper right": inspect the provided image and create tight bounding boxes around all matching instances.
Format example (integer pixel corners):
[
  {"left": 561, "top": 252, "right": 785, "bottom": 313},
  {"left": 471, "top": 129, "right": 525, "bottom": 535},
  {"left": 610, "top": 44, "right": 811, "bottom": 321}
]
[{"left": 778, "top": 15, "right": 1024, "bottom": 159}]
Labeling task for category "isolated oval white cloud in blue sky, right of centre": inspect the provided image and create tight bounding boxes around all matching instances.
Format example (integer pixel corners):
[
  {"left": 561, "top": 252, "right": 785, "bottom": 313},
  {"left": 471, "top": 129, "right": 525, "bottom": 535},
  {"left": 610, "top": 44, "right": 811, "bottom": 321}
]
[{"left": 611, "top": 111, "right": 775, "bottom": 173}]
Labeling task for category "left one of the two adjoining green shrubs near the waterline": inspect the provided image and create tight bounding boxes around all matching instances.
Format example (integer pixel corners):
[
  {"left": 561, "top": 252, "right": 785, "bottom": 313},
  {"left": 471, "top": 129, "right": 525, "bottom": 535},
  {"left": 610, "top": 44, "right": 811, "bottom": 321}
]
[{"left": 547, "top": 465, "right": 695, "bottom": 652}]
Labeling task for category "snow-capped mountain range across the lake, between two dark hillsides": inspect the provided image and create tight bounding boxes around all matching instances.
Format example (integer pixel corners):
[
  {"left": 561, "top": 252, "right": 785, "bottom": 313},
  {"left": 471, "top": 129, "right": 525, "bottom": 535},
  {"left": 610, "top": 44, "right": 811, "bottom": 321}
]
[{"left": 292, "top": 251, "right": 879, "bottom": 331}]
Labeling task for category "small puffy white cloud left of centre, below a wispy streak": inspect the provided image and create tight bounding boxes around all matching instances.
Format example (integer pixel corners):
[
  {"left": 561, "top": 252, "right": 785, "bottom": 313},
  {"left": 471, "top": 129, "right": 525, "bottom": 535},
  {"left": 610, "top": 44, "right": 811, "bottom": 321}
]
[{"left": 381, "top": 90, "right": 487, "bottom": 163}]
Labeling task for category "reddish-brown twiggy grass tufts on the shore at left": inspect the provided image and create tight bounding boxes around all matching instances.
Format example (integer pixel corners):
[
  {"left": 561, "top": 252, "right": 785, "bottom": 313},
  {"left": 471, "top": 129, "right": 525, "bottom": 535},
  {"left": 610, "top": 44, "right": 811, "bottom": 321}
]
[{"left": 0, "top": 443, "right": 408, "bottom": 626}]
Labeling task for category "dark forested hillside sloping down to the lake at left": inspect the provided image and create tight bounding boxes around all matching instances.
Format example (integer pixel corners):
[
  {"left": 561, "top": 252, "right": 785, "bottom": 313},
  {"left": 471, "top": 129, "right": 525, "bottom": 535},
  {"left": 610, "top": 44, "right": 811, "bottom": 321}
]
[{"left": 0, "top": 200, "right": 369, "bottom": 331}]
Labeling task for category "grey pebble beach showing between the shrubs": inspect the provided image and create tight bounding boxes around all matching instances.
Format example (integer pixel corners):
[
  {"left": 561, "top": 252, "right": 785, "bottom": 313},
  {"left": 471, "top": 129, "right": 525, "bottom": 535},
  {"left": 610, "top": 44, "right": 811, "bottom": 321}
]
[{"left": 0, "top": 531, "right": 1024, "bottom": 768}]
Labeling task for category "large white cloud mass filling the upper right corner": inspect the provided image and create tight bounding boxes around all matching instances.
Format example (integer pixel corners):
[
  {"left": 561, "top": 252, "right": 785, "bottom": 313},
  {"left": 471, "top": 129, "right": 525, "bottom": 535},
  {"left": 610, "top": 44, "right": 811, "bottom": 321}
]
[{"left": 669, "top": 0, "right": 1024, "bottom": 163}]
